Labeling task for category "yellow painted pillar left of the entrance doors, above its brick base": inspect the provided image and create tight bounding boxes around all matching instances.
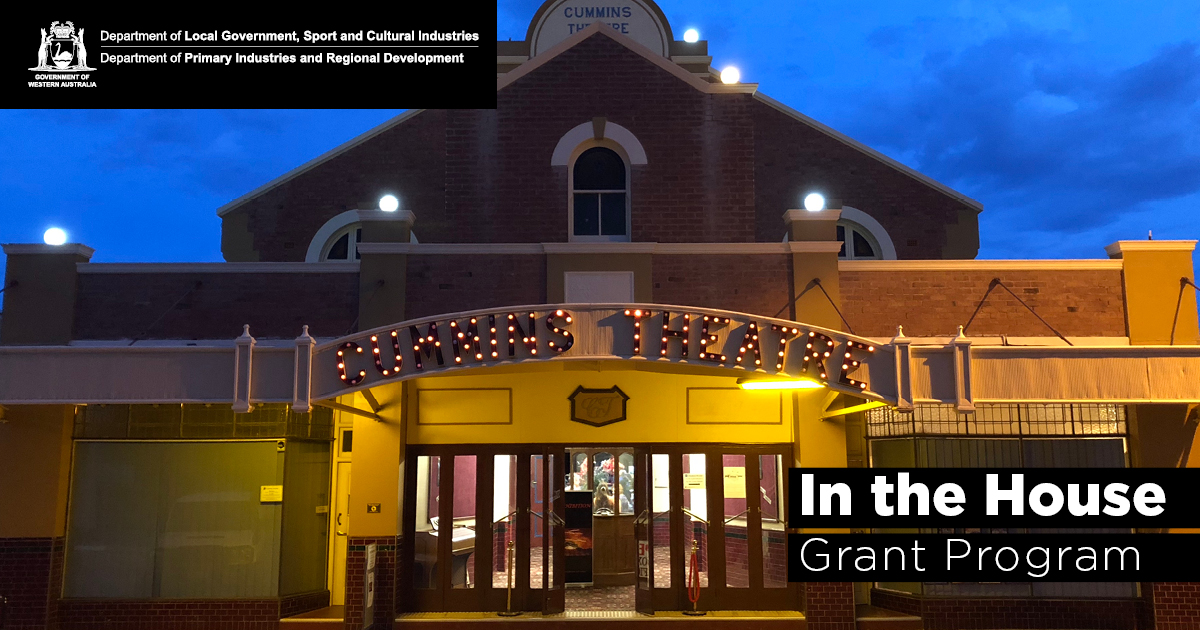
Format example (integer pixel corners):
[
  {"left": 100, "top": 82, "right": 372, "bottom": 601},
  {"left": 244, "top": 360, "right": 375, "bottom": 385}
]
[{"left": 338, "top": 383, "right": 404, "bottom": 536}]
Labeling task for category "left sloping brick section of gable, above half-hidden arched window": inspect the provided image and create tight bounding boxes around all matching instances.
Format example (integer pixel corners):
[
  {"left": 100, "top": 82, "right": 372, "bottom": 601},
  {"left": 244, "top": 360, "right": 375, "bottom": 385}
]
[{"left": 226, "top": 110, "right": 446, "bottom": 262}]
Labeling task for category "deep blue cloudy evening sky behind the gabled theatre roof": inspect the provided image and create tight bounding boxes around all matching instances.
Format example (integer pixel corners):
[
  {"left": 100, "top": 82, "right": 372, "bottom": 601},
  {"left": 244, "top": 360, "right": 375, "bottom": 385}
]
[{"left": 0, "top": 0, "right": 1200, "bottom": 280}]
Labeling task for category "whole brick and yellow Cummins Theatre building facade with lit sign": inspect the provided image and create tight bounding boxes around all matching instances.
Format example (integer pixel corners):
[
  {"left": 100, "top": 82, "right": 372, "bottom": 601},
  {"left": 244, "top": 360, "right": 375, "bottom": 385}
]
[{"left": 0, "top": 0, "right": 1200, "bottom": 630}]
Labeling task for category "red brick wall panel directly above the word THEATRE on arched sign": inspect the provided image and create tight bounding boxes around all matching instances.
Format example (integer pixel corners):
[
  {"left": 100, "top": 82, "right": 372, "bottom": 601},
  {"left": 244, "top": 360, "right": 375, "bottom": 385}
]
[{"left": 653, "top": 254, "right": 792, "bottom": 318}]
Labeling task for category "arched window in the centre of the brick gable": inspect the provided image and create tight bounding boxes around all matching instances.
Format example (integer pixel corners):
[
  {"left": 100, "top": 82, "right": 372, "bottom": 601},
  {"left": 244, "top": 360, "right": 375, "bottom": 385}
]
[{"left": 570, "top": 146, "right": 629, "bottom": 241}]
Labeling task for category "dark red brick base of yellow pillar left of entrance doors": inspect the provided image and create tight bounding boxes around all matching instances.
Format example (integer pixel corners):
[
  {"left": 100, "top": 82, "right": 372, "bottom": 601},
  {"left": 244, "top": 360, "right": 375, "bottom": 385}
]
[{"left": 343, "top": 536, "right": 398, "bottom": 630}]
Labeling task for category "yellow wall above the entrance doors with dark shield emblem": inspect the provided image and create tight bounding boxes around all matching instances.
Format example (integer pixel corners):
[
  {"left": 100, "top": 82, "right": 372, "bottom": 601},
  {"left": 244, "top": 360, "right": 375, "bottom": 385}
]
[{"left": 403, "top": 362, "right": 845, "bottom": 444}]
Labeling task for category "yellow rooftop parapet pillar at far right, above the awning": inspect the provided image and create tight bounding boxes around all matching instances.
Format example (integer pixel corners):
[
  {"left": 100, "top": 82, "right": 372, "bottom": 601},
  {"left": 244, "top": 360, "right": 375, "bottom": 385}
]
[{"left": 1122, "top": 247, "right": 1200, "bottom": 346}]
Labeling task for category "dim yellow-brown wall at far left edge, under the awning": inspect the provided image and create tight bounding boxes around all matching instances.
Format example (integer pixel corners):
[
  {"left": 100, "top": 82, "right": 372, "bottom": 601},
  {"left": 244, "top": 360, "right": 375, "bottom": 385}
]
[{"left": 0, "top": 404, "right": 74, "bottom": 538}]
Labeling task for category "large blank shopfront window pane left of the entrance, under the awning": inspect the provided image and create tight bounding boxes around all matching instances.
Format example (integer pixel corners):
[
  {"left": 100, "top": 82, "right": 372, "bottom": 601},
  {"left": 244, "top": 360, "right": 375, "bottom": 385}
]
[{"left": 64, "top": 442, "right": 283, "bottom": 599}]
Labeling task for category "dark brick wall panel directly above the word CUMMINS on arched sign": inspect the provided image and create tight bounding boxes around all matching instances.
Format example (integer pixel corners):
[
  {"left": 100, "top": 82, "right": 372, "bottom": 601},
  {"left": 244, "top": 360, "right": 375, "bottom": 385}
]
[{"left": 406, "top": 254, "right": 546, "bottom": 319}]
